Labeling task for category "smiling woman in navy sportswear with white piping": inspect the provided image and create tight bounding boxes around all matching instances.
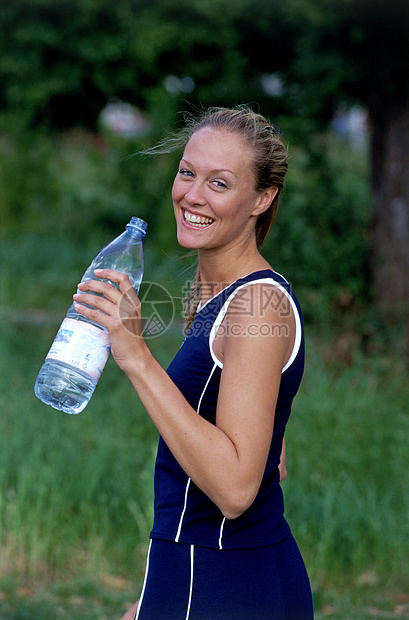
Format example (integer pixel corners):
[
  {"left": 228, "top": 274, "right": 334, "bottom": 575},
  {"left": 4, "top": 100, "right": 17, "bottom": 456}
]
[{"left": 74, "top": 107, "right": 313, "bottom": 620}]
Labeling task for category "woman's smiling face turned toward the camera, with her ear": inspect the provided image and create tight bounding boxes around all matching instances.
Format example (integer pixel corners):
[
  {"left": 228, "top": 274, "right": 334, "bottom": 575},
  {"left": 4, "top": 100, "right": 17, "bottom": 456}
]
[{"left": 172, "top": 127, "right": 274, "bottom": 250}]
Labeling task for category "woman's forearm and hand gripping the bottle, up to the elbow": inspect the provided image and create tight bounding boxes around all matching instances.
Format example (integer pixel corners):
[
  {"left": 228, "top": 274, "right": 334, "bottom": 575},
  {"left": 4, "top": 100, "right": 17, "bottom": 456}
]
[{"left": 74, "top": 270, "right": 245, "bottom": 511}]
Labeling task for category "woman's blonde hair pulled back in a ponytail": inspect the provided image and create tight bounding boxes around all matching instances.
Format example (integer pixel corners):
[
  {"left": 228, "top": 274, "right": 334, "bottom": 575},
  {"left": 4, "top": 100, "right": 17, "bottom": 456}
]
[{"left": 153, "top": 105, "right": 287, "bottom": 330}]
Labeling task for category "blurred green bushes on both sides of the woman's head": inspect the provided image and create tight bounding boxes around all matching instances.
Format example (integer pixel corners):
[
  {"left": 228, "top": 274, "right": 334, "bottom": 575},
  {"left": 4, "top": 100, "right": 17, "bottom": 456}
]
[{"left": 0, "top": 119, "right": 370, "bottom": 328}]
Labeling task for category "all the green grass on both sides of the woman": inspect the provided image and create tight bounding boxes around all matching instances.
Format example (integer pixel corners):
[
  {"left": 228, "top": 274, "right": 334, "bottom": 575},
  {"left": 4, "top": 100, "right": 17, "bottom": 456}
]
[{"left": 0, "top": 314, "right": 409, "bottom": 620}]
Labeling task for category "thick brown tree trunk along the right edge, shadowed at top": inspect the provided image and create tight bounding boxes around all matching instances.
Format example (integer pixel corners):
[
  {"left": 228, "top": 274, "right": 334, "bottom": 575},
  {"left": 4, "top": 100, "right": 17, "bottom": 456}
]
[{"left": 353, "top": 0, "right": 409, "bottom": 340}]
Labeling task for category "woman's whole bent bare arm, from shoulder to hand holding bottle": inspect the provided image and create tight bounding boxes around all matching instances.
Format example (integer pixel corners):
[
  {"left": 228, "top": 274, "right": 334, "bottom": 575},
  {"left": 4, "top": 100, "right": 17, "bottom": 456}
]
[{"left": 71, "top": 270, "right": 293, "bottom": 519}]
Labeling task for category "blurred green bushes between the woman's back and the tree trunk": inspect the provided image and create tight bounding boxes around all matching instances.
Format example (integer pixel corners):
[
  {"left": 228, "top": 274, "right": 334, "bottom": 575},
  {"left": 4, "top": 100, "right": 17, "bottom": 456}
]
[{"left": 264, "top": 132, "right": 371, "bottom": 327}]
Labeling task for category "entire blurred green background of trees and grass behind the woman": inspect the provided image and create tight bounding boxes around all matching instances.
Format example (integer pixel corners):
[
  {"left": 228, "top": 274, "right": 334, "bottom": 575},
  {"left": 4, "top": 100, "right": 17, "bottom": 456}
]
[{"left": 0, "top": 0, "right": 409, "bottom": 620}]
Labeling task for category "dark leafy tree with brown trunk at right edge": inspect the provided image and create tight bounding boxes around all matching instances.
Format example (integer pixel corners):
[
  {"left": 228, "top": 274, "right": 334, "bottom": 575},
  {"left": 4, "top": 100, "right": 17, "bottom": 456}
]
[{"left": 236, "top": 0, "right": 409, "bottom": 344}]
